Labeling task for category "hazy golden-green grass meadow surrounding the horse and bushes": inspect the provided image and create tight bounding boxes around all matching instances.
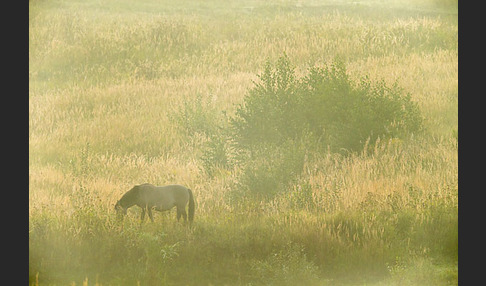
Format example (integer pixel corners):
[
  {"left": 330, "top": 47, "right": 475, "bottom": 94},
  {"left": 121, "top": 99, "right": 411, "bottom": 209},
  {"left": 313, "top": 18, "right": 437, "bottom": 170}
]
[{"left": 29, "top": 0, "right": 458, "bottom": 285}]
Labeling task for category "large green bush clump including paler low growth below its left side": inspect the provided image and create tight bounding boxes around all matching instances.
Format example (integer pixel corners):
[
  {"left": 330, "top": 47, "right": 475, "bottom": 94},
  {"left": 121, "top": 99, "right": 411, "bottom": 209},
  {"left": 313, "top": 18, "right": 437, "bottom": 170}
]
[{"left": 227, "top": 55, "right": 422, "bottom": 199}]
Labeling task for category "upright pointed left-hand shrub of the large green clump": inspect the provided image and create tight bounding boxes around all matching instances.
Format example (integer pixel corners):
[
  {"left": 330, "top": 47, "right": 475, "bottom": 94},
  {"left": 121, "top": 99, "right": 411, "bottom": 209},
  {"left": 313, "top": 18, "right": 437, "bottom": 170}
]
[{"left": 231, "top": 56, "right": 302, "bottom": 150}]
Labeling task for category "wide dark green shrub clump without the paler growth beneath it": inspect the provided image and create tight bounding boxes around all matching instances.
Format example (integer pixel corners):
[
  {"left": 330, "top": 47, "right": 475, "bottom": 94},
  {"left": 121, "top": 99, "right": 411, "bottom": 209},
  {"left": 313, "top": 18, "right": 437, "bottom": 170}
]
[{"left": 232, "top": 55, "right": 422, "bottom": 155}]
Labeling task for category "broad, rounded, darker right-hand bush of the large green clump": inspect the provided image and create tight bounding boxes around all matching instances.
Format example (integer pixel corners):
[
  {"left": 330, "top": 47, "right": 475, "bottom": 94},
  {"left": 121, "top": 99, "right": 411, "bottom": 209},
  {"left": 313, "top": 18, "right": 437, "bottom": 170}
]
[{"left": 302, "top": 65, "right": 422, "bottom": 151}]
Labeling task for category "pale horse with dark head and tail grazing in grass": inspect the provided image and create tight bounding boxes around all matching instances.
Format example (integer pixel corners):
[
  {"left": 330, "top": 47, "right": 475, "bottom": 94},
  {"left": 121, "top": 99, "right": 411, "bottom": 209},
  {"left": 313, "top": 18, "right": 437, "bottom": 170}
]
[{"left": 115, "top": 184, "right": 194, "bottom": 225}]
